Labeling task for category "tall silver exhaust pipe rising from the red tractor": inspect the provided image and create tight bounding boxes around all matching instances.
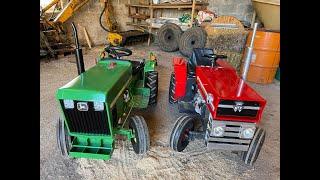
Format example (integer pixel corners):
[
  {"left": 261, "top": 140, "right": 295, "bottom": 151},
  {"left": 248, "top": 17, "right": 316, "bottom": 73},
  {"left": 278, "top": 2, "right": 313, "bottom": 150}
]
[{"left": 237, "top": 23, "right": 258, "bottom": 97}]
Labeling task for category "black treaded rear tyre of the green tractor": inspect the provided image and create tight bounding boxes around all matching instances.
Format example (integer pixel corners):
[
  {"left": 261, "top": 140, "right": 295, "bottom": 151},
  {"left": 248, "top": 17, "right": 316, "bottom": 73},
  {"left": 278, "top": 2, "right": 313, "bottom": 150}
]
[{"left": 146, "top": 71, "right": 158, "bottom": 105}]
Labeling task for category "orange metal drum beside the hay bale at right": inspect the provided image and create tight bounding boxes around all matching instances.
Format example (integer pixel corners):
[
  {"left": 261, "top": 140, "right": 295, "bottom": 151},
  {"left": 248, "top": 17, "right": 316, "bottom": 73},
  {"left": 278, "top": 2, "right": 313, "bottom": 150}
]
[{"left": 241, "top": 30, "right": 280, "bottom": 84}]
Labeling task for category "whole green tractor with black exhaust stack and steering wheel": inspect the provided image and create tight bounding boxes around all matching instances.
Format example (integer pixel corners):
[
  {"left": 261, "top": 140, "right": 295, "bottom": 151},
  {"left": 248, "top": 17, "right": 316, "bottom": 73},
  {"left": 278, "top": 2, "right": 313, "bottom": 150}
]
[{"left": 56, "top": 24, "right": 158, "bottom": 160}]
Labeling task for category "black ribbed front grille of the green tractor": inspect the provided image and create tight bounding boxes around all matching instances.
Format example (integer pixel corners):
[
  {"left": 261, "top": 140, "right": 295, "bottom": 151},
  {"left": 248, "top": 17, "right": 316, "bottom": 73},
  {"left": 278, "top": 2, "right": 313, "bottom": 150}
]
[{"left": 60, "top": 100, "right": 110, "bottom": 135}]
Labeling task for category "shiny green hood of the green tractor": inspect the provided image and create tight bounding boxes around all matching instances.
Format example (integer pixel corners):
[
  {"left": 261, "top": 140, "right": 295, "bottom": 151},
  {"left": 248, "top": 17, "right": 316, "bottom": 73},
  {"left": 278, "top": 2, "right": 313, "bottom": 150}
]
[{"left": 57, "top": 60, "right": 132, "bottom": 104}]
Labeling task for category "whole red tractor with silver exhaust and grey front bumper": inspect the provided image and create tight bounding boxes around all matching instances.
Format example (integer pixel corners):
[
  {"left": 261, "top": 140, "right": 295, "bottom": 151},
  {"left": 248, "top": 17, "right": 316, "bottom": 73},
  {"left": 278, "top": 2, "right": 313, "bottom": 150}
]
[{"left": 169, "top": 25, "right": 266, "bottom": 165}]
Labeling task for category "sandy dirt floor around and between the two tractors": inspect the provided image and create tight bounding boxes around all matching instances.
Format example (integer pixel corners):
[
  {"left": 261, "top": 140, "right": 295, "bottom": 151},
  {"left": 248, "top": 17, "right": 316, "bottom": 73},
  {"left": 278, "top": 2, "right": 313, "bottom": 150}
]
[{"left": 40, "top": 45, "right": 280, "bottom": 180}]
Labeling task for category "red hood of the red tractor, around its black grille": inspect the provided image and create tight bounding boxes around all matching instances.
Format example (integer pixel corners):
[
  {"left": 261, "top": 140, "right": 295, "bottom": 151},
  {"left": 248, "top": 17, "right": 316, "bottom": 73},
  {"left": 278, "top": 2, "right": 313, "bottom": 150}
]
[{"left": 196, "top": 60, "right": 266, "bottom": 123}]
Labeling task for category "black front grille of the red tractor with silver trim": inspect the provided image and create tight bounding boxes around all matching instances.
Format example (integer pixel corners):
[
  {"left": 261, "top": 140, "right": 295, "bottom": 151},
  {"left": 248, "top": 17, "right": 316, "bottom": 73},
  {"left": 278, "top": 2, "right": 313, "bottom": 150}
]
[{"left": 217, "top": 100, "right": 260, "bottom": 118}]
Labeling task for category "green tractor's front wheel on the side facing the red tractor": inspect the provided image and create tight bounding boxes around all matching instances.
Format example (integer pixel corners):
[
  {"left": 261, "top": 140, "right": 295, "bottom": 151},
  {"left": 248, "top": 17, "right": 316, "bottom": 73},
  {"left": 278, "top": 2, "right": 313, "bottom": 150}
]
[{"left": 129, "top": 116, "right": 150, "bottom": 154}]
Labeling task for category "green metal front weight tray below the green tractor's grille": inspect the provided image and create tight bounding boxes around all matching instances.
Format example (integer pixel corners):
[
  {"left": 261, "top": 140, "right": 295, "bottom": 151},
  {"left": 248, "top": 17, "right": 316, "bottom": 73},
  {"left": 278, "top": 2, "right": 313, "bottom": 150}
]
[{"left": 69, "top": 136, "right": 114, "bottom": 160}]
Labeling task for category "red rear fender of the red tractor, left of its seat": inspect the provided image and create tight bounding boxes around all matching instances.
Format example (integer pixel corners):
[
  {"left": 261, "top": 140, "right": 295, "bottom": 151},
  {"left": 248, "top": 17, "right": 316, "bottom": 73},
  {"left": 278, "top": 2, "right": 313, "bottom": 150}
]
[{"left": 173, "top": 57, "right": 187, "bottom": 100}]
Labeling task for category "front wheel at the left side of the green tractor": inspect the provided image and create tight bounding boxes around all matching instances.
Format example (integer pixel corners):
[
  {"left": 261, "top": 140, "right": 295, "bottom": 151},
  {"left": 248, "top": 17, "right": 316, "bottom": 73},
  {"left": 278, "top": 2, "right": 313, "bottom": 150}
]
[{"left": 56, "top": 118, "right": 71, "bottom": 156}]
